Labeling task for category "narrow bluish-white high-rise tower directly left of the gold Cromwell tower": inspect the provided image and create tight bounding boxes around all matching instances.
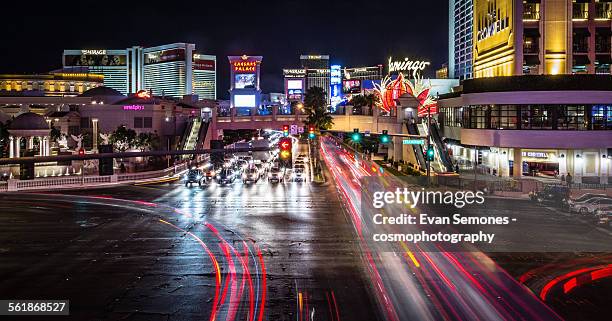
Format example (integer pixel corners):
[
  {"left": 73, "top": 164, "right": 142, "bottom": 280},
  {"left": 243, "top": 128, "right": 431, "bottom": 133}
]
[{"left": 448, "top": 0, "right": 474, "bottom": 79}]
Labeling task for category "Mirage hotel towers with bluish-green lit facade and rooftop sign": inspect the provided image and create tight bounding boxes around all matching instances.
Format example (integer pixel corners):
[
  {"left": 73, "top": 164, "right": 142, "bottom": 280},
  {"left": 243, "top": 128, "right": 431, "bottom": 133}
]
[{"left": 63, "top": 43, "right": 217, "bottom": 99}]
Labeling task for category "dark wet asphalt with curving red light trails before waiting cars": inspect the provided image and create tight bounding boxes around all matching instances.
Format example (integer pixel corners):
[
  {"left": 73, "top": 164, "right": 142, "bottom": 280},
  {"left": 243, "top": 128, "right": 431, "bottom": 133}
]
[{"left": 0, "top": 156, "right": 379, "bottom": 321}]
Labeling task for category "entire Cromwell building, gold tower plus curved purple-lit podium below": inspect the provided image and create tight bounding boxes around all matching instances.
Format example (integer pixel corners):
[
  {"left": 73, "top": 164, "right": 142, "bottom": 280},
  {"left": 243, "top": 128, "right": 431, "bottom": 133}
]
[{"left": 439, "top": 0, "right": 612, "bottom": 184}]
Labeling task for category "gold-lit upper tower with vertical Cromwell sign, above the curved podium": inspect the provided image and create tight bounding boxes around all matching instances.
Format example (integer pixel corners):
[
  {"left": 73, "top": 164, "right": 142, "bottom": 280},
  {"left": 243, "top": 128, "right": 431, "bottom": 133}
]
[{"left": 473, "top": 0, "right": 612, "bottom": 77}]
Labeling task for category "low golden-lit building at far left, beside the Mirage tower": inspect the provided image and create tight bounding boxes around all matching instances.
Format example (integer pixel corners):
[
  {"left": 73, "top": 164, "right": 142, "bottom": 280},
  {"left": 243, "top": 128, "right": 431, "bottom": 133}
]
[{"left": 0, "top": 72, "right": 104, "bottom": 96}]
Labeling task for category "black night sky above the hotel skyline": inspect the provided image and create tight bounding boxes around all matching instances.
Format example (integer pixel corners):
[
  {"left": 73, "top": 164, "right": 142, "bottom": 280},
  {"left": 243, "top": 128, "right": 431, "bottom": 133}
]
[{"left": 0, "top": 0, "right": 448, "bottom": 98}]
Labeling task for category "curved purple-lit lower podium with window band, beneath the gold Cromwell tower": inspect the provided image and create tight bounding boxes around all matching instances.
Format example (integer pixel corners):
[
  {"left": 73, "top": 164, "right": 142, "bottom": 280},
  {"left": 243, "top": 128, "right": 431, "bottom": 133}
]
[{"left": 438, "top": 75, "right": 612, "bottom": 184}]
